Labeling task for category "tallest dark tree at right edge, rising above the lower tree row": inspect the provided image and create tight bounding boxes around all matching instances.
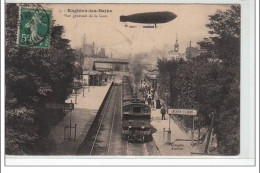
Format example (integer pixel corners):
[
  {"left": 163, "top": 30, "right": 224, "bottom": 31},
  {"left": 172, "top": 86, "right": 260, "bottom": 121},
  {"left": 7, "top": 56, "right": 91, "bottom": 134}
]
[{"left": 199, "top": 5, "right": 240, "bottom": 155}]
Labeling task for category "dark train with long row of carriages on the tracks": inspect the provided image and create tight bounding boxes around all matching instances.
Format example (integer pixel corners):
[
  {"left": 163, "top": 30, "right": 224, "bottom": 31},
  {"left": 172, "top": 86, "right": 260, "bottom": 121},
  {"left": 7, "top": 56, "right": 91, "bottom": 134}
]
[{"left": 121, "top": 76, "right": 152, "bottom": 142}]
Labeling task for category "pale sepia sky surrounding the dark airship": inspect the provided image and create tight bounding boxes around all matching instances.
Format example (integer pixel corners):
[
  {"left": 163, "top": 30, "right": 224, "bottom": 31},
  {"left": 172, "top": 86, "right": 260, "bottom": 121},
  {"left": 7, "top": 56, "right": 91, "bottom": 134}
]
[{"left": 44, "top": 4, "right": 230, "bottom": 58}]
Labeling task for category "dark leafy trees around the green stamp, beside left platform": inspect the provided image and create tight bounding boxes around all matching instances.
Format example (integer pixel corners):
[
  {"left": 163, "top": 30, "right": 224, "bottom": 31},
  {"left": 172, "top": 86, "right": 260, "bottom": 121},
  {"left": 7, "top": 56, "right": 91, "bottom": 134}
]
[{"left": 5, "top": 4, "right": 80, "bottom": 154}]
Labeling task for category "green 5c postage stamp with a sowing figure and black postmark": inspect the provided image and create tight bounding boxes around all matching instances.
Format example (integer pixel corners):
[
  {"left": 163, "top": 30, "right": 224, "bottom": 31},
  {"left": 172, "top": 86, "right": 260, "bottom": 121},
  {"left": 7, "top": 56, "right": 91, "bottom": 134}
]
[{"left": 18, "top": 7, "right": 52, "bottom": 48}]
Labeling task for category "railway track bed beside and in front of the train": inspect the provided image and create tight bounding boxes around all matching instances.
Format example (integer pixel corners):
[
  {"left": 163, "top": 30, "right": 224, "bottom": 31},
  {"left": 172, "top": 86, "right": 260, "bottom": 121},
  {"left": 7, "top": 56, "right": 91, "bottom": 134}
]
[{"left": 78, "top": 86, "right": 159, "bottom": 156}]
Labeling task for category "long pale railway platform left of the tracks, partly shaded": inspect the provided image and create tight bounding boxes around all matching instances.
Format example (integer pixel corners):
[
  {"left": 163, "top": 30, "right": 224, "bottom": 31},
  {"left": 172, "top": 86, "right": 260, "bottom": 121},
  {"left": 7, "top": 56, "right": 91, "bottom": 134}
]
[{"left": 48, "top": 83, "right": 111, "bottom": 155}]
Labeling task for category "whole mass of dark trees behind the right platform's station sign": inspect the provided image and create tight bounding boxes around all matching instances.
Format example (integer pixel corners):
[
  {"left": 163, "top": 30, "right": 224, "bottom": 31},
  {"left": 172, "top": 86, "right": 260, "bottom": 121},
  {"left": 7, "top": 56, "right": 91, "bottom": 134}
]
[{"left": 158, "top": 5, "right": 240, "bottom": 155}]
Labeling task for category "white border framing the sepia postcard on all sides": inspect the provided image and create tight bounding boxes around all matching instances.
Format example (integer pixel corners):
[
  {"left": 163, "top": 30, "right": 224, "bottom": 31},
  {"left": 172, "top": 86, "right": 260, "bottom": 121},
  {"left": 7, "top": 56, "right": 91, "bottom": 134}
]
[{"left": 1, "top": 0, "right": 259, "bottom": 166}]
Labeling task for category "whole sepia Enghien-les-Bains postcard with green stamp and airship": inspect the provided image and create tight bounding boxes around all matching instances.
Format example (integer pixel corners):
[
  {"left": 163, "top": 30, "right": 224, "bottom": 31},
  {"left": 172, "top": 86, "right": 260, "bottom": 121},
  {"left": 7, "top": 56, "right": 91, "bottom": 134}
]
[{"left": 4, "top": 3, "right": 256, "bottom": 166}]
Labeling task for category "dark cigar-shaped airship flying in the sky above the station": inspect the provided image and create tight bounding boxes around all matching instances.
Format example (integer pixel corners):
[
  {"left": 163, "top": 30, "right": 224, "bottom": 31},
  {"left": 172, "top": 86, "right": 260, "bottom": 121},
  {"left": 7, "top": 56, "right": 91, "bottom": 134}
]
[{"left": 120, "top": 11, "right": 177, "bottom": 28}]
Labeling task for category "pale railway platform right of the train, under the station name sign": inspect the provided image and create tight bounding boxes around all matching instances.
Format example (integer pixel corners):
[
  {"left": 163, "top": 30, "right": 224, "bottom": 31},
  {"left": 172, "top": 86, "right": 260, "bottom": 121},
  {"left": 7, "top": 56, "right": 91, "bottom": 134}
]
[{"left": 151, "top": 109, "right": 204, "bottom": 156}]
